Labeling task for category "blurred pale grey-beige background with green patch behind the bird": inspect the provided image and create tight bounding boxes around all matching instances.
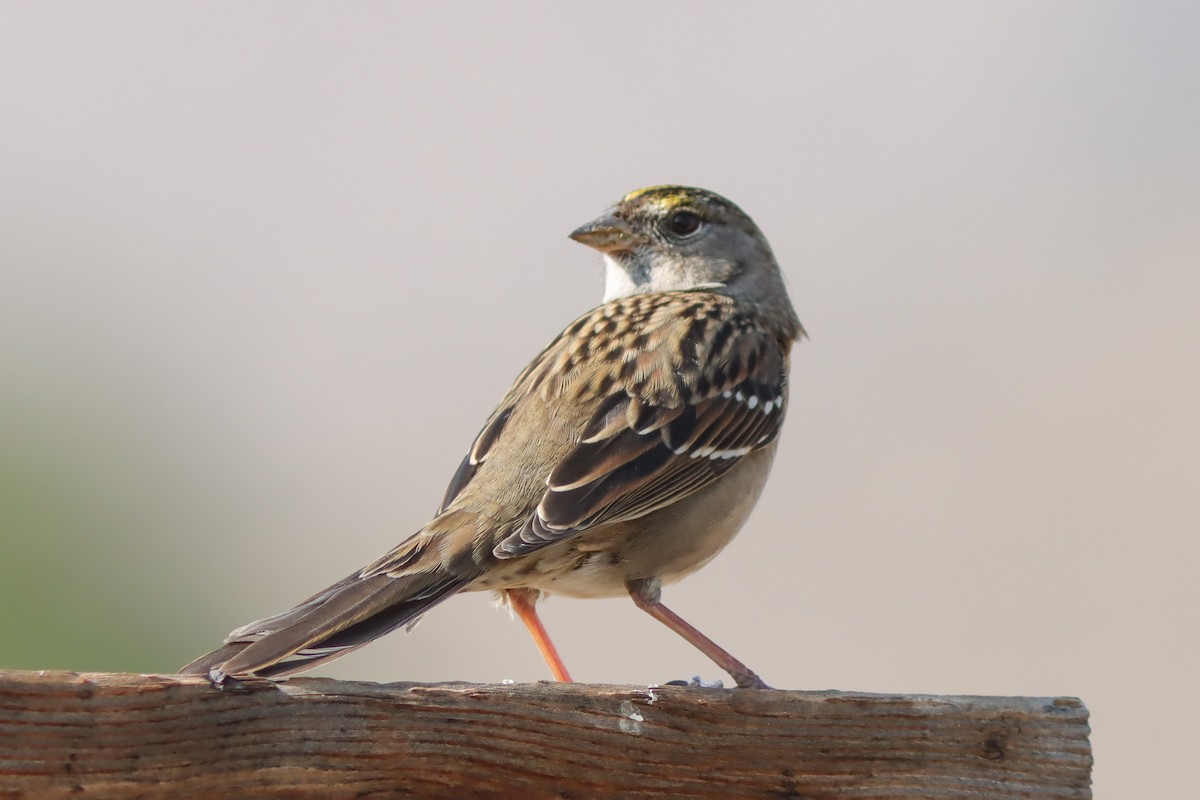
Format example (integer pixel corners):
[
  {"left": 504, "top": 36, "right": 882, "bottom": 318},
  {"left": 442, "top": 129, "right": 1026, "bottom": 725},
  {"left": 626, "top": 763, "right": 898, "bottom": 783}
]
[{"left": 0, "top": 1, "right": 1200, "bottom": 798}]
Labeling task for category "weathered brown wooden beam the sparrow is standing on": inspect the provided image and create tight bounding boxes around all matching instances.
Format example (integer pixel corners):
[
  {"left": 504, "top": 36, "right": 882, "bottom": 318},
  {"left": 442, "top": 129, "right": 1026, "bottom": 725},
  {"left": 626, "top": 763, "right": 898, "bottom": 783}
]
[{"left": 0, "top": 672, "right": 1092, "bottom": 800}]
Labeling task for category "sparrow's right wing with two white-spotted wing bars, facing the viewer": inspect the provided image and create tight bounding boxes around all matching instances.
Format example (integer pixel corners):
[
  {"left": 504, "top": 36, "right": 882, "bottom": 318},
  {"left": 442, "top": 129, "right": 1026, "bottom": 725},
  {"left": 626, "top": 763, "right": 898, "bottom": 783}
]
[{"left": 494, "top": 319, "right": 787, "bottom": 558}]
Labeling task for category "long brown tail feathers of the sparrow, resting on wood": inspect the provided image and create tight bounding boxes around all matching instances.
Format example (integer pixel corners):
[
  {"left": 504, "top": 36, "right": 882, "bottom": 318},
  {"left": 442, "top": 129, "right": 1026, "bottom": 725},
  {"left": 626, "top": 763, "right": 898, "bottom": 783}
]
[{"left": 179, "top": 537, "right": 475, "bottom": 678}]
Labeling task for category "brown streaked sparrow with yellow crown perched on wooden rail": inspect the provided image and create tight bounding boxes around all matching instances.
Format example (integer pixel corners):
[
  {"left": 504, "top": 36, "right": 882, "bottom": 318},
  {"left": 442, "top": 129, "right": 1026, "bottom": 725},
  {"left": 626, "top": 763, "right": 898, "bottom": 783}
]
[{"left": 180, "top": 185, "right": 805, "bottom": 688}]
